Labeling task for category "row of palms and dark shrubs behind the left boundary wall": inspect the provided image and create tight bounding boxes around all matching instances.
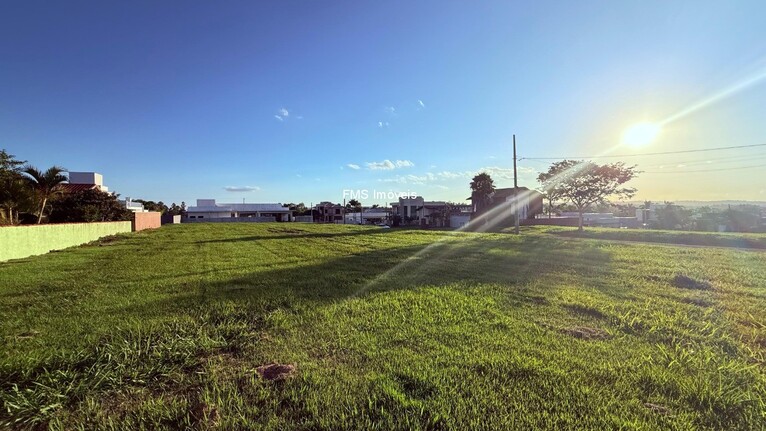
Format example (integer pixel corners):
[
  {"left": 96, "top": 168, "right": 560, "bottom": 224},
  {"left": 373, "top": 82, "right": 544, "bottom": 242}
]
[{"left": 0, "top": 150, "right": 186, "bottom": 225}]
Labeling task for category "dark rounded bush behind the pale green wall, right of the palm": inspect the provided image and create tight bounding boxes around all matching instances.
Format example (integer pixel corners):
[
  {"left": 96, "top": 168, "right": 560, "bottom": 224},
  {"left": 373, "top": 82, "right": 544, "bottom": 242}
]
[{"left": 50, "top": 190, "right": 133, "bottom": 223}]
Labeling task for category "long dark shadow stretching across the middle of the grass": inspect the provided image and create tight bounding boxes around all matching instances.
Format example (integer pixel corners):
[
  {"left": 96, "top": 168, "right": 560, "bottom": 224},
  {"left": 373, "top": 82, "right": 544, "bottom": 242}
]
[{"left": 115, "top": 233, "right": 620, "bottom": 315}]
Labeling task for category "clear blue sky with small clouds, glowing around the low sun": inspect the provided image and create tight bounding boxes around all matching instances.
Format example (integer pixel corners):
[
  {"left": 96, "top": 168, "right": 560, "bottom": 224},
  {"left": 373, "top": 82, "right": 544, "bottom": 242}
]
[{"left": 0, "top": 1, "right": 766, "bottom": 204}]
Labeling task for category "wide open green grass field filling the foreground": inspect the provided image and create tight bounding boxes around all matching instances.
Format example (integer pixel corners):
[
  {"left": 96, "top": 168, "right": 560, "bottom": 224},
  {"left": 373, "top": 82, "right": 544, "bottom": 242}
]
[{"left": 0, "top": 223, "right": 766, "bottom": 430}]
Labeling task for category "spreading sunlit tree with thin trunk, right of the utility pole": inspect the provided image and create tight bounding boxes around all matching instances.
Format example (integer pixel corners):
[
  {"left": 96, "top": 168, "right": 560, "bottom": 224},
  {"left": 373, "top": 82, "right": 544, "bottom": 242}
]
[{"left": 538, "top": 160, "right": 637, "bottom": 230}]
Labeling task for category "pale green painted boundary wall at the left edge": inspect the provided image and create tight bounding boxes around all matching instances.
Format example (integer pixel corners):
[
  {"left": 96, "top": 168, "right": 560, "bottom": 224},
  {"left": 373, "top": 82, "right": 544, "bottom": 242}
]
[{"left": 0, "top": 221, "right": 131, "bottom": 262}]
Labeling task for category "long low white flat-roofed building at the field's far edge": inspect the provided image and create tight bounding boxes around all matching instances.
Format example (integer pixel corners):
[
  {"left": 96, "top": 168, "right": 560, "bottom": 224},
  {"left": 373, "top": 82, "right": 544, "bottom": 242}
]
[{"left": 184, "top": 199, "right": 292, "bottom": 222}]
